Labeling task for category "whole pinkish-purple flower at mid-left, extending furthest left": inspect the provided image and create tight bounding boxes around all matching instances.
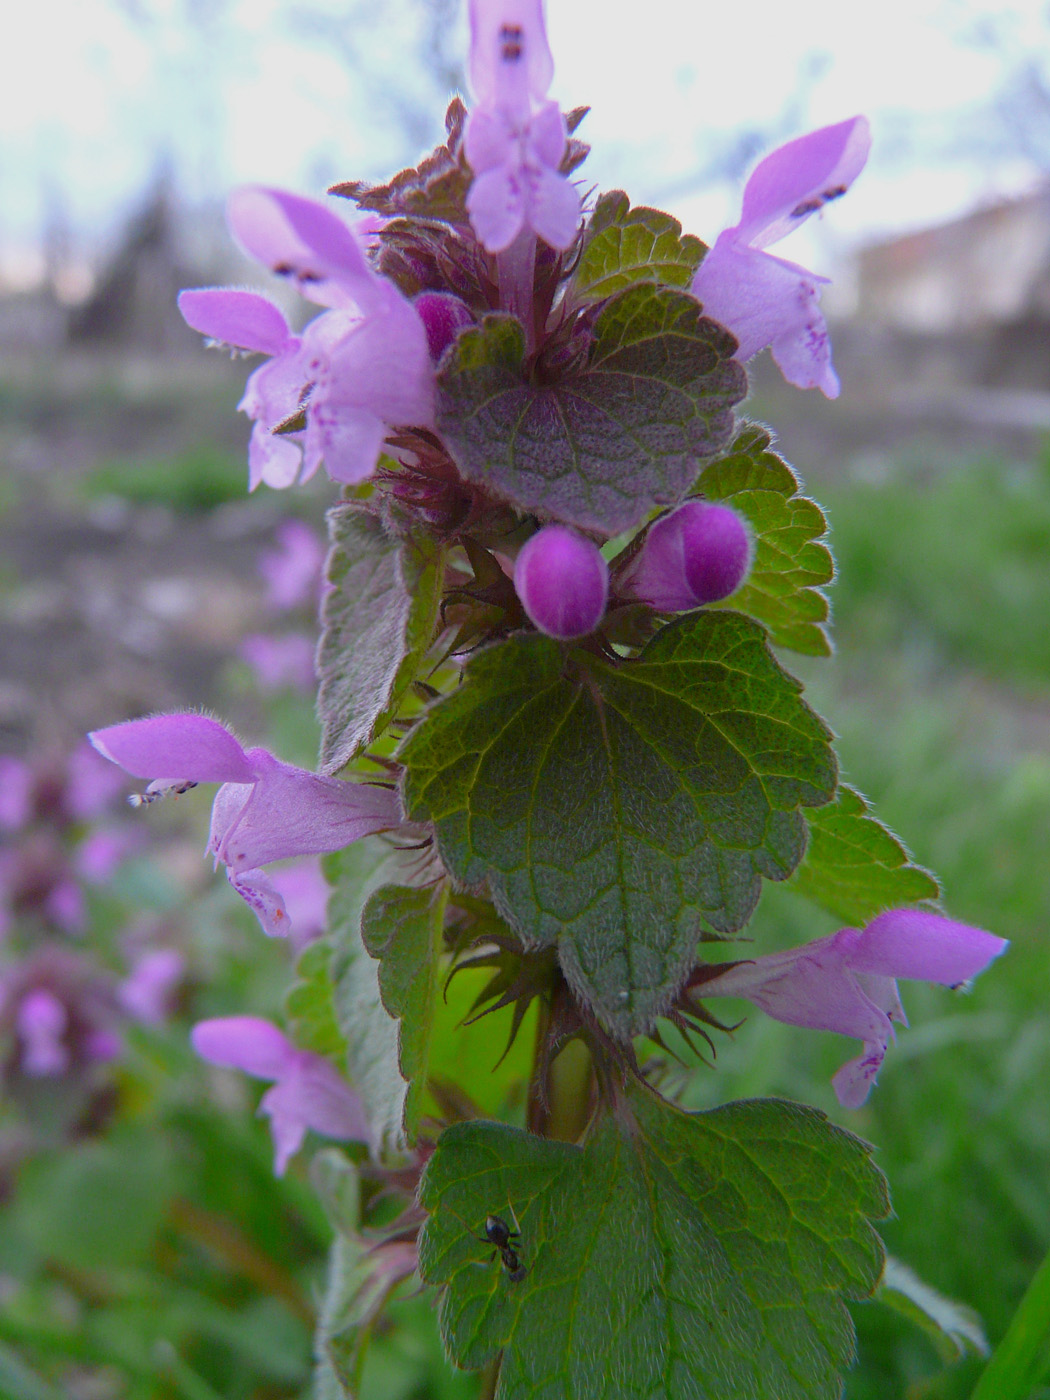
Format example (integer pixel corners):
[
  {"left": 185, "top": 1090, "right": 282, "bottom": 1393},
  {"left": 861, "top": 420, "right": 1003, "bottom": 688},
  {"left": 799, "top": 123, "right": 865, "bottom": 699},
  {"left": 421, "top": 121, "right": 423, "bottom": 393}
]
[{"left": 90, "top": 714, "right": 400, "bottom": 934}]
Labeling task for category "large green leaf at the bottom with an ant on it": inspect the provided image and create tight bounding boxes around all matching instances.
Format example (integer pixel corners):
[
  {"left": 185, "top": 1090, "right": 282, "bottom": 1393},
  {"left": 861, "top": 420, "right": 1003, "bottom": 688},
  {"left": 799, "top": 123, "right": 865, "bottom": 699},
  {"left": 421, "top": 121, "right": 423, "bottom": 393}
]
[{"left": 420, "top": 1089, "right": 889, "bottom": 1400}]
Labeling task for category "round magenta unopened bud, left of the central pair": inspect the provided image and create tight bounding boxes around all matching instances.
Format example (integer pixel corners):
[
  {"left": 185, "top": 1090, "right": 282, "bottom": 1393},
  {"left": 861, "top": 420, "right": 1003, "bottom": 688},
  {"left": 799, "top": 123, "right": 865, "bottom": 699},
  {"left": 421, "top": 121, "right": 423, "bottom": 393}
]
[{"left": 514, "top": 525, "right": 609, "bottom": 641}]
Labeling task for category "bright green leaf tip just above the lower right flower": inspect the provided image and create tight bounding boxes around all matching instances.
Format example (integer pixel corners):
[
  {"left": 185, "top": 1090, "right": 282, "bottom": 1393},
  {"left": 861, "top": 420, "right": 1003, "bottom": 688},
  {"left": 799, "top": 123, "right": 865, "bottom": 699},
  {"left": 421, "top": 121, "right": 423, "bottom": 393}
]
[{"left": 795, "top": 785, "right": 941, "bottom": 925}]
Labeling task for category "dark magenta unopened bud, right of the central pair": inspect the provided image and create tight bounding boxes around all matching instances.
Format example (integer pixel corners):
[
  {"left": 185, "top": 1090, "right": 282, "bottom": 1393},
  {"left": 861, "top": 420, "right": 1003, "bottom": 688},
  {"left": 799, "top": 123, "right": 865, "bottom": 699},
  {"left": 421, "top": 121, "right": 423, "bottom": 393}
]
[{"left": 619, "top": 501, "right": 752, "bottom": 612}]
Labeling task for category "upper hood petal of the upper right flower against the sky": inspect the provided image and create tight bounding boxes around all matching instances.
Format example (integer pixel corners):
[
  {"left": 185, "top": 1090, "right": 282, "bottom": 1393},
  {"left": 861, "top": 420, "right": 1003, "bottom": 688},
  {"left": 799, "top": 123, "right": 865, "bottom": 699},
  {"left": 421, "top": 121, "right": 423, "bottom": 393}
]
[{"left": 734, "top": 116, "right": 871, "bottom": 248}]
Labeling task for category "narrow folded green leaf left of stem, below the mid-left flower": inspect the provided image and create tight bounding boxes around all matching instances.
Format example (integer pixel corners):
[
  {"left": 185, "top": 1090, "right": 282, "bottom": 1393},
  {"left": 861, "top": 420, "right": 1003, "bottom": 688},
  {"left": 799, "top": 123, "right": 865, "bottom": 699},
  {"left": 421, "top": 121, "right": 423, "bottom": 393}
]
[{"left": 361, "top": 883, "right": 448, "bottom": 1137}]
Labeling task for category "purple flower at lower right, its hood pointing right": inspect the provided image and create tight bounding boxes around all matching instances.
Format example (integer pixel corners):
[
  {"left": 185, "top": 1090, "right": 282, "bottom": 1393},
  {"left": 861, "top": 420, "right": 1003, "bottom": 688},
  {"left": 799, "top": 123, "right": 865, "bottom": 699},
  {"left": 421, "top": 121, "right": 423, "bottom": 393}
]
[{"left": 696, "top": 909, "right": 1007, "bottom": 1109}]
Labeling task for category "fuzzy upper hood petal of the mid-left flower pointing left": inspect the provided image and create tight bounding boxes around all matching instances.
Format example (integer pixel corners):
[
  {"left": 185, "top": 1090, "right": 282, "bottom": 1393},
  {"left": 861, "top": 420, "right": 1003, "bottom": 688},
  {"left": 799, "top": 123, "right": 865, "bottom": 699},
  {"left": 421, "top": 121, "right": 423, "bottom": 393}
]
[{"left": 88, "top": 714, "right": 255, "bottom": 783}]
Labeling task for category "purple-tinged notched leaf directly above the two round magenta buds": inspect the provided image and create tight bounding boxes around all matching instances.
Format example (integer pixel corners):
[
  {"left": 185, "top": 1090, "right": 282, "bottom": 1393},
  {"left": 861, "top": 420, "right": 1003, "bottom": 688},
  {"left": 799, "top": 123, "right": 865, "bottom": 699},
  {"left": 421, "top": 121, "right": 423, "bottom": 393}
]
[{"left": 438, "top": 284, "right": 746, "bottom": 535}]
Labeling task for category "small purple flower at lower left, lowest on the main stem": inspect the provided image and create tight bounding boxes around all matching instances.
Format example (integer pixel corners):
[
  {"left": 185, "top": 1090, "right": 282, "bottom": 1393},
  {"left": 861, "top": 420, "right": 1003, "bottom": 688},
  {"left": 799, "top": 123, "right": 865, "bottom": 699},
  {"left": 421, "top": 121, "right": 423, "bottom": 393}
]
[{"left": 190, "top": 1016, "right": 368, "bottom": 1176}]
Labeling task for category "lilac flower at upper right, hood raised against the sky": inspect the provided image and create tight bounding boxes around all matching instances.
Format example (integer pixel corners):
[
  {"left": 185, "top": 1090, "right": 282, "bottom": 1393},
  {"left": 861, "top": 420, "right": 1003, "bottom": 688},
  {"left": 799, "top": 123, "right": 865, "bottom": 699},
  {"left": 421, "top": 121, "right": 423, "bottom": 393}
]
[{"left": 693, "top": 116, "right": 871, "bottom": 399}]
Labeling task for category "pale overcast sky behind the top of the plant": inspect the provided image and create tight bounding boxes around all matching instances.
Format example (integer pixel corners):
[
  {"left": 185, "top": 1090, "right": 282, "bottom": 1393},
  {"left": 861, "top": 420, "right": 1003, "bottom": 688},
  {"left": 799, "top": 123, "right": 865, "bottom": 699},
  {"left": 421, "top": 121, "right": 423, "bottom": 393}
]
[{"left": 0, "top": 0, "right": 1050, "bottom": 281}]
